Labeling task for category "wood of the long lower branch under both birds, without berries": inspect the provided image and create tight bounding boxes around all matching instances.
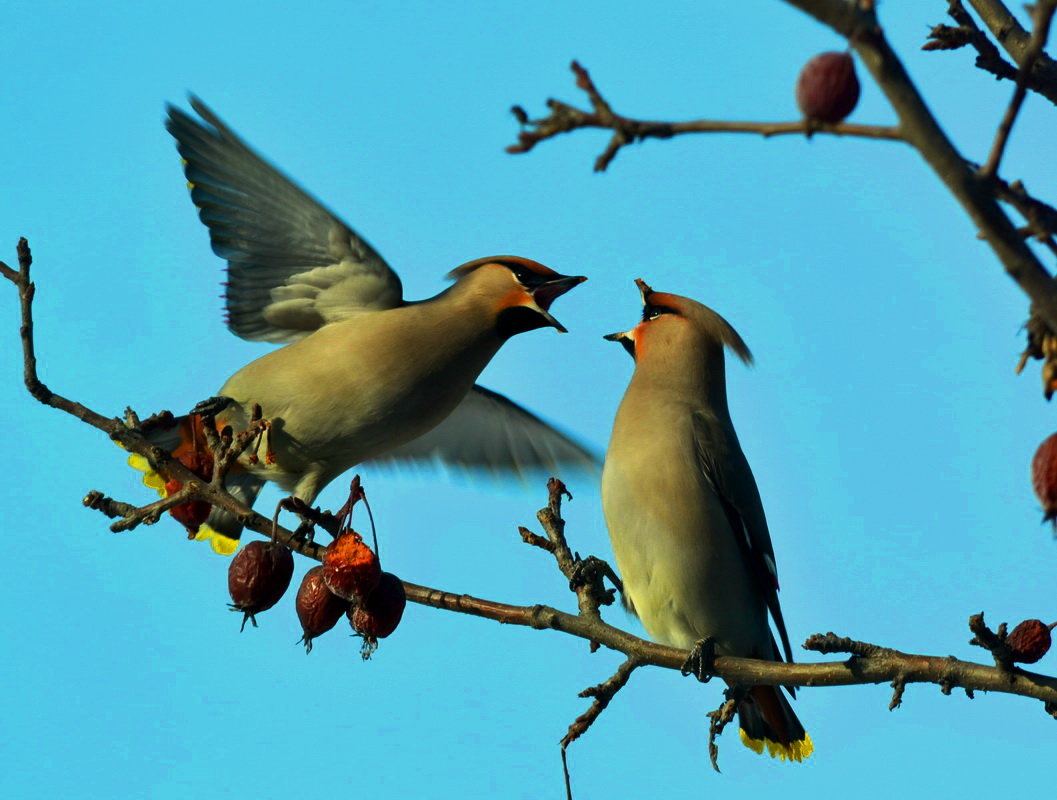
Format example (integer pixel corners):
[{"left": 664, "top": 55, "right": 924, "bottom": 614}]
[{"left": 6, "top": 240, "right": 1057, "bottom": 773}]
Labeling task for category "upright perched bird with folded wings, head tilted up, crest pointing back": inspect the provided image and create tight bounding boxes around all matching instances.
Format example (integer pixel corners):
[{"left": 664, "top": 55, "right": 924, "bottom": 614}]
[{"left": 601, "top": 280, "right": 813, "bottom": 761}]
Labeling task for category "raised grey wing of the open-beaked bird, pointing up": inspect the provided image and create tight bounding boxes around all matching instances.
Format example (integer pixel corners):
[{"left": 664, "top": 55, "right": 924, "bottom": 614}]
[{"left": 166, "top": 97, "right": 402, "bottom": 341}]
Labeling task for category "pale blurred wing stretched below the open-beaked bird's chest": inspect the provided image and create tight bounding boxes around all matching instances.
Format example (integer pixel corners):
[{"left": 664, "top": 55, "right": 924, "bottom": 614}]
[{"left": 371, "top": 386, "right": 601, "bottom": 478}]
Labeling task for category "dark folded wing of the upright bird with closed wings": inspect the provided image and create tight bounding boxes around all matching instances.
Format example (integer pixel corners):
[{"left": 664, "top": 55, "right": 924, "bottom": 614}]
[{"left": 693, "top": 413, "right": 793, "bottom": 662}]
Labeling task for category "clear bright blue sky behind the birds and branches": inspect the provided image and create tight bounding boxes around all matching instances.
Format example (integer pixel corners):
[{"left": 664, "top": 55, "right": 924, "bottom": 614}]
[{"left": 0, "top": 0, "right": 1057, "bottom": 798}]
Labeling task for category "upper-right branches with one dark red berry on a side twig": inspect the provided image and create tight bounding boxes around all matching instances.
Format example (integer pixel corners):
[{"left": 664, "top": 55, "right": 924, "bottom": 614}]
[{"left": 506, "top": 0, "right": 1057, "bottom": 380}]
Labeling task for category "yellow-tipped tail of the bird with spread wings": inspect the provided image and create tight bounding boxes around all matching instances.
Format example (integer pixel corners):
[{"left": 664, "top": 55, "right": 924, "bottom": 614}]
[{"left": 129, "top": 414, "right": 262, "bottom": 556}]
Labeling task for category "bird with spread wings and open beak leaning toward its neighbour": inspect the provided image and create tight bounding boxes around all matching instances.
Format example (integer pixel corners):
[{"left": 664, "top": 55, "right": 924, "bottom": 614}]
[{"left": 127, "top": 98, "right": 597, "bottom": 553}]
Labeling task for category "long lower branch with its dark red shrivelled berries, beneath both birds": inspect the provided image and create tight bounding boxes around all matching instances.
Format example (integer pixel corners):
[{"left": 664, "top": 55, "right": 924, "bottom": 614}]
[{"left": 6, "top": 239, "right": 1057, "bottom": 785}]
